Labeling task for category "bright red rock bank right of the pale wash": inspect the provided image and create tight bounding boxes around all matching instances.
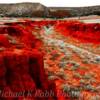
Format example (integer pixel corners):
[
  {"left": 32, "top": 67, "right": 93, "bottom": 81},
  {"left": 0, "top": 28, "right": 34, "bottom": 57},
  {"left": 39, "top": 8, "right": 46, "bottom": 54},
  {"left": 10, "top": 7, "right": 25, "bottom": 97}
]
[{"left": 55, "top": 21, "right": 100, "bottom": 44}]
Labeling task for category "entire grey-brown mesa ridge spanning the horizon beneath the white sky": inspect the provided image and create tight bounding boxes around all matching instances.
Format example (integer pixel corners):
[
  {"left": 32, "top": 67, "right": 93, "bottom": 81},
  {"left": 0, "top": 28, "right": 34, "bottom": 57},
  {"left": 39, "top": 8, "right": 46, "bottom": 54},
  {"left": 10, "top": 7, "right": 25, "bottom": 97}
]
[{"left": 0, "top": 2, "right": 100, "bottom": 18}]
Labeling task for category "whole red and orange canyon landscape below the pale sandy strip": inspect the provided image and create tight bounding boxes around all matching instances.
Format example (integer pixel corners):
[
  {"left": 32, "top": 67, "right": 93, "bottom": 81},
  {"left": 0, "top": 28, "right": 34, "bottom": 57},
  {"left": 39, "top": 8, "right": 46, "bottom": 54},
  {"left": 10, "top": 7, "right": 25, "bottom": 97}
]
[{"left": 0, "top": 19, "right": 100, "bottom": 100}]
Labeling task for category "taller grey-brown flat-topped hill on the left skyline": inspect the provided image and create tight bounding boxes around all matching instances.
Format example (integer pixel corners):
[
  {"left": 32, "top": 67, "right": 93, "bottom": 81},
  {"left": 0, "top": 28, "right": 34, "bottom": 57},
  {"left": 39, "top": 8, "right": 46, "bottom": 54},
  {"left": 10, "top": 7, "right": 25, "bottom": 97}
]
[{"left": 0, "top": 3, "right": 48, "bottom": 17}]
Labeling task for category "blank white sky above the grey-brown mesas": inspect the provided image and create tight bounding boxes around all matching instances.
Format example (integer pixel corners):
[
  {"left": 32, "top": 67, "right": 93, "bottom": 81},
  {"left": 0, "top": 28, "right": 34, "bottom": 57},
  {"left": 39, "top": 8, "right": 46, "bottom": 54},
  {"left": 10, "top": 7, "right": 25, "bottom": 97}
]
[{"left": 0, "top": 0, "right": 100, "bottom": 7}]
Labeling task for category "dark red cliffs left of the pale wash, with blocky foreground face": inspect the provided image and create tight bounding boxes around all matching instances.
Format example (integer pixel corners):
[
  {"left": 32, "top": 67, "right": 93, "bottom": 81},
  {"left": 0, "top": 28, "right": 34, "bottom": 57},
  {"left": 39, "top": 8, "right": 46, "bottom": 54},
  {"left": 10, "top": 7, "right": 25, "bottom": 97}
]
[{"left": 0, "top": 22, "right": 57, "bottom": 100}]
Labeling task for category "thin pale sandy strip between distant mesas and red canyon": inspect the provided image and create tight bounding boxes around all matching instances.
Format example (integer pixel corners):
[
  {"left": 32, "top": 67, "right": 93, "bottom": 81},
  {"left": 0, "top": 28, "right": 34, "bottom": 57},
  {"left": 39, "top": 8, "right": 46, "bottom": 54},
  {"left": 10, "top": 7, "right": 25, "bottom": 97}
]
[{"left": 0, "top": 15, "right": 100, "bottom": 24}]
